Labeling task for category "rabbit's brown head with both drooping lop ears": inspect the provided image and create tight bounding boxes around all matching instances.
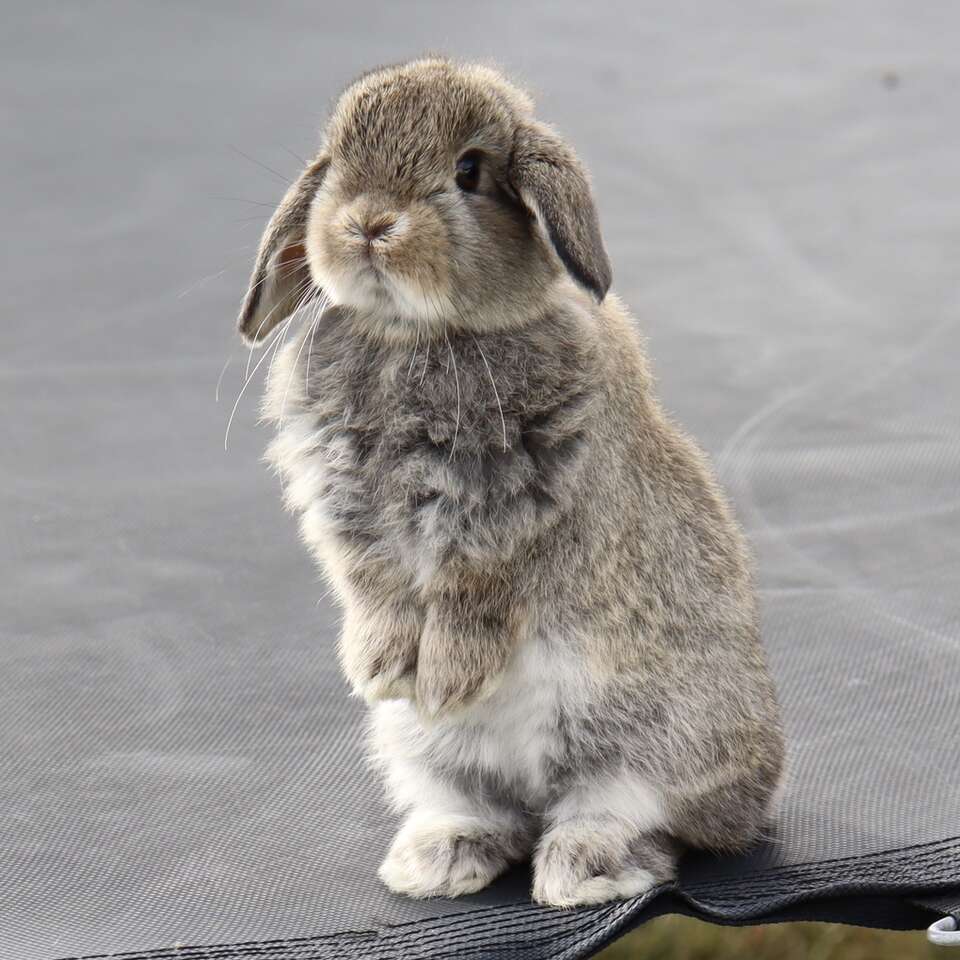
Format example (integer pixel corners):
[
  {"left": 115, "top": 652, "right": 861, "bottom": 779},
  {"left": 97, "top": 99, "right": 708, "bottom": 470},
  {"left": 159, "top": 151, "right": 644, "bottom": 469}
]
[{"left": 239, "top": 59, "right": 610, "bottom": 343}]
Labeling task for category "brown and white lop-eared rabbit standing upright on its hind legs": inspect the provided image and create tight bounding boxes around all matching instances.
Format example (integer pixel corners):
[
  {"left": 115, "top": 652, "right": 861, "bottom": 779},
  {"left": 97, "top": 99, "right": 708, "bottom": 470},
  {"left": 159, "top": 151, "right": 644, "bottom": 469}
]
[{"left": 238, "top": 57, "right": 784, "bottom": 907}]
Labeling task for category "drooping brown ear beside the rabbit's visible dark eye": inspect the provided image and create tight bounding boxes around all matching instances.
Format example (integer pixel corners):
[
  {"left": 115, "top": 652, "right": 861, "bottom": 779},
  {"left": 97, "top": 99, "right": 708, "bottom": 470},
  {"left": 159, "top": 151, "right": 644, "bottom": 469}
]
[{"left": 509, "top": 121, "right": 612, "bottom": 301}]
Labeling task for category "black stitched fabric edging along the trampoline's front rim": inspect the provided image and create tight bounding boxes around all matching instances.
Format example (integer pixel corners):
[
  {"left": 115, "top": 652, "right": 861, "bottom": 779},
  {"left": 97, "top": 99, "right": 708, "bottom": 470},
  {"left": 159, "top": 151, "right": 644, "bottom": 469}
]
[{"left": 63, "top": 837, "right": 960, "bottom": 960}]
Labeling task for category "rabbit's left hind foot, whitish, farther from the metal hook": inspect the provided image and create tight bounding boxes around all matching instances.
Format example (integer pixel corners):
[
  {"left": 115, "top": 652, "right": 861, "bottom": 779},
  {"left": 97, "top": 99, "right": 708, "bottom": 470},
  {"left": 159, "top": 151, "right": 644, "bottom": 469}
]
[{"left": 379, "top": 816, "right": 523, "bottom": 898}]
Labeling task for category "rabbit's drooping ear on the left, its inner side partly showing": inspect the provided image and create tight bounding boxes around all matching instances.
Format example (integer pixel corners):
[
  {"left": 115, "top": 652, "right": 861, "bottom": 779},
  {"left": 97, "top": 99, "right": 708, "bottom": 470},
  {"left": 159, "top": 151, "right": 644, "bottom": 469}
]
[{"left": 237, "top": 154, "right": 329, "bottom": 345}]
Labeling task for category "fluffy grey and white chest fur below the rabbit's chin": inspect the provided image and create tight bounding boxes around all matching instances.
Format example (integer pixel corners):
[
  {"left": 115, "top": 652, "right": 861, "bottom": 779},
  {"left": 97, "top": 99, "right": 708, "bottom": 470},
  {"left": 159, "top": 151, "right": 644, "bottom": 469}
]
[{"left": 266, "top": 316, "right": 585, "bottom": 585}]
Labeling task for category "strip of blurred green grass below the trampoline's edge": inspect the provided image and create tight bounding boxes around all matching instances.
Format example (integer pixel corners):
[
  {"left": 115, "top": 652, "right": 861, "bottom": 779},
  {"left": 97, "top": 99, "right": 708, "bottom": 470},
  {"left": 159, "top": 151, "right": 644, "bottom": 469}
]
[{"left": 597, "top": 917, "right": 940, "bottom": 960}]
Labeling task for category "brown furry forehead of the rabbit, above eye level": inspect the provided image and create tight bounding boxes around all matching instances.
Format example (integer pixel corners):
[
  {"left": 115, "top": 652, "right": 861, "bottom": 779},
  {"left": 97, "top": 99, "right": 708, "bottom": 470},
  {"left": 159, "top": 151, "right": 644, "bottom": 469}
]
[{"left": 327, "top": 72, "right": 516, "bottom": 169}]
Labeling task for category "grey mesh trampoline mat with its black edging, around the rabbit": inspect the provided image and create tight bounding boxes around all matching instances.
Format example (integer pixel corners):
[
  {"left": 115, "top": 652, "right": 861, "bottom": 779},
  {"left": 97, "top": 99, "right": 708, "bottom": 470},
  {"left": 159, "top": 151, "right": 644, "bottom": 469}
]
[{"left": 0, "top": 2, "right": 960, "bottom": 960}]
